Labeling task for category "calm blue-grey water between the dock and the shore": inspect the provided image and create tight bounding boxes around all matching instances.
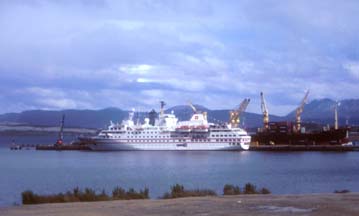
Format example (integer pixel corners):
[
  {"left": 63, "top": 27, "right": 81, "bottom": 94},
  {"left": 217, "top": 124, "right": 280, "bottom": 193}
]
[{"left": 0, "top": 136, "right": 359, "bottom": 206}]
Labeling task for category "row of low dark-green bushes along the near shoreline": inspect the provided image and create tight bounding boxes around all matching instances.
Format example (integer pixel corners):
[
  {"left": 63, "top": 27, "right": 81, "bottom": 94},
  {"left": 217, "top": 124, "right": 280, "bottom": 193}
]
[{"left": 21, "top": 183, "right": 270, "bottom": 205}]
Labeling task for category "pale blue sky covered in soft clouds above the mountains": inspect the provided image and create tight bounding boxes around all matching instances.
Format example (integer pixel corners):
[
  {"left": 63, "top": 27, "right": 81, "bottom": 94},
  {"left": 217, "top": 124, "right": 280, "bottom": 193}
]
[{"left": 0, "top": 0, "right": 359, "bottom": 114}]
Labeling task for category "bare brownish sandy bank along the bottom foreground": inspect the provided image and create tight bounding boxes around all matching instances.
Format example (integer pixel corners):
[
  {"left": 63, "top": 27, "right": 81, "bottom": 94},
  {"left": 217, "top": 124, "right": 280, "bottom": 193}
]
[{"left": 0, "top": 193, "right": 359, "bottom": 216}]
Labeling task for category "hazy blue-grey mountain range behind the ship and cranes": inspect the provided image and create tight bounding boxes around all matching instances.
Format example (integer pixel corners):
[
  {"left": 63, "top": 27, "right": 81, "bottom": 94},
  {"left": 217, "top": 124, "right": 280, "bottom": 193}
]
[{"left": 0, "top": 99, "right": 359, "bottom": 128}]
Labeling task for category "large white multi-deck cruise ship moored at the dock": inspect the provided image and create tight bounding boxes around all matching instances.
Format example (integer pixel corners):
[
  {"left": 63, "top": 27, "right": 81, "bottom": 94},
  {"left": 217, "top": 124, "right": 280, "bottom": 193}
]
[{"left": 87, "top": 102, "right": 251, "bottom": 151}]
